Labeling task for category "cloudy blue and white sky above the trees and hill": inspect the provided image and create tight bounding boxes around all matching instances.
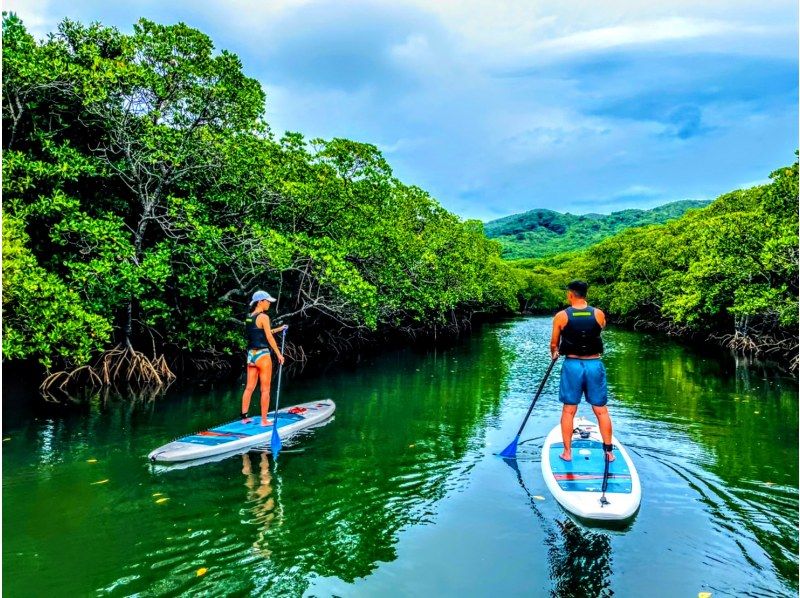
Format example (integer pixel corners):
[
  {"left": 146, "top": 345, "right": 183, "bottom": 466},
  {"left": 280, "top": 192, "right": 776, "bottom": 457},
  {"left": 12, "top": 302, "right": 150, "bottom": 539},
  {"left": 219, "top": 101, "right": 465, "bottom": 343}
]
[{"left": 3, "top": 0, "right": 798, "bottom": 220}]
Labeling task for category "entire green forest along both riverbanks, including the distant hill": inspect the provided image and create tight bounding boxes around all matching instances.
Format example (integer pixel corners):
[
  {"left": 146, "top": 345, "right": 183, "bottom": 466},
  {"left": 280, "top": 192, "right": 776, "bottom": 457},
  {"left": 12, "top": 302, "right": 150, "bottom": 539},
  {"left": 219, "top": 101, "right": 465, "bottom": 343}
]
[{"left": 2, "top": 15, "right": 798, "bottom": 384}]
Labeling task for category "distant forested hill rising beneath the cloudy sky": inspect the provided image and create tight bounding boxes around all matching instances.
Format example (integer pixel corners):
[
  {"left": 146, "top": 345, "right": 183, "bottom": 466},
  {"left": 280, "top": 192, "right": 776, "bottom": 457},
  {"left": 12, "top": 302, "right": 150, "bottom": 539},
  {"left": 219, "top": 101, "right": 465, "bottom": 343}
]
[{"left": 484, "top": 200, "right": 709, "bottom": 259}]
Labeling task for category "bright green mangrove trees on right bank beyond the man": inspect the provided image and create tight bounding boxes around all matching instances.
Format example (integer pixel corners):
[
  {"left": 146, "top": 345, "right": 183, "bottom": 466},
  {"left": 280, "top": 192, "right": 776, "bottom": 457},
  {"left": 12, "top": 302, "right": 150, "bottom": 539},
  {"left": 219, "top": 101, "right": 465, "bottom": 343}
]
[{"left": 514, "top": 162, "right": 798, "bottom": 342}]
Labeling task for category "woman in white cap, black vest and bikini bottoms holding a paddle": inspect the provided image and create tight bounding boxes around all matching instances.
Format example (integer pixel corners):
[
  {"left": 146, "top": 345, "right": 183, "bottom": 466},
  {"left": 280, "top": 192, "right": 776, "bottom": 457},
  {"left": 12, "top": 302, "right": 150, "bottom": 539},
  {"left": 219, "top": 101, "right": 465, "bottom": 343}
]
[{"left": 242, "top": 291, "right": 286, "bottom": 426}]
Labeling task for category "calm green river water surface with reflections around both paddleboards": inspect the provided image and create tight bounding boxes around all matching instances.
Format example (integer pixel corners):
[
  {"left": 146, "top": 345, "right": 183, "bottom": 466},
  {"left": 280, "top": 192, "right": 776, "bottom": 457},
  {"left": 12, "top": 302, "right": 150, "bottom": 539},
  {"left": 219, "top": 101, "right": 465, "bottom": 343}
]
[{"left": 3, "top": 318, "right": 798, "bottom": 598}]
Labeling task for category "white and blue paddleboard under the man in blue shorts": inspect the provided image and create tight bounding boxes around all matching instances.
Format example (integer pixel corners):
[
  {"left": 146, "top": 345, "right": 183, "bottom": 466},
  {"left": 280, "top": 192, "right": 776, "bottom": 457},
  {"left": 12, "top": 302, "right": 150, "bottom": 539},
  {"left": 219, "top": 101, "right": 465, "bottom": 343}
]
[{"left": 542, "top": 417, "right": 642, "bottom": 521}]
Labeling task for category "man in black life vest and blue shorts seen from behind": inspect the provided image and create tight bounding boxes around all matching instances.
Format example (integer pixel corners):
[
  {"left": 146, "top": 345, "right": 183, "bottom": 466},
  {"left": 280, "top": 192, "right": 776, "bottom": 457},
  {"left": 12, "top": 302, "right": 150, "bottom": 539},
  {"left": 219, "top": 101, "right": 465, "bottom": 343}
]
[{"left": 550, "top": 280, "right": 614, "bottom": 461}]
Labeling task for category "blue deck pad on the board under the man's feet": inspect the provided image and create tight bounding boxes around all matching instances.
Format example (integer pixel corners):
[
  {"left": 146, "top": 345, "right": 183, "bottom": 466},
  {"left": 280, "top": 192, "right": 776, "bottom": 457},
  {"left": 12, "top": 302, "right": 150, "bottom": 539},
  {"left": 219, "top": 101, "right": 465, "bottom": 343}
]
[{"left": 550, "top": 439, "right": 632, "bottom": 494}]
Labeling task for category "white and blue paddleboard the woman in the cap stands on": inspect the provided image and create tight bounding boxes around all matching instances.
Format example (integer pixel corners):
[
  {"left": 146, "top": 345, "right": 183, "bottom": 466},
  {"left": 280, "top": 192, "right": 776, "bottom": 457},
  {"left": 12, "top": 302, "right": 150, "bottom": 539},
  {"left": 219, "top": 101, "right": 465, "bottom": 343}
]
[{"left": 147, "top": 399, "right": 336, "bottom": 463}]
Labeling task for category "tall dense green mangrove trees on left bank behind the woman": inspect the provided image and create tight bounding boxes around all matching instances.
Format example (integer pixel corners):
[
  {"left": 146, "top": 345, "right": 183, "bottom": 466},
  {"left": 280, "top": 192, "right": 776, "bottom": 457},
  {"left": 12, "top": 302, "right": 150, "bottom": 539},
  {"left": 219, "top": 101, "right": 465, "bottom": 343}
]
[{"left": 3, "top": 15, "right": 517, "bottom": 367}]
